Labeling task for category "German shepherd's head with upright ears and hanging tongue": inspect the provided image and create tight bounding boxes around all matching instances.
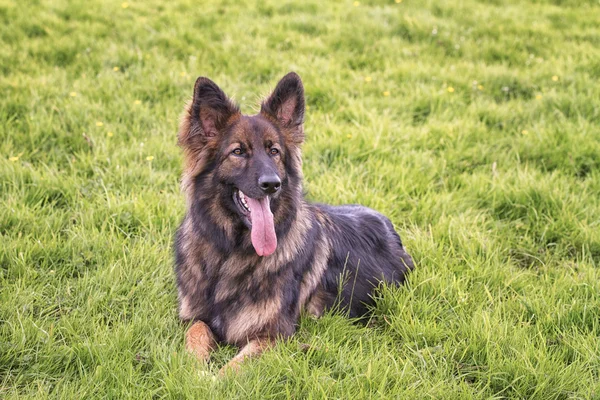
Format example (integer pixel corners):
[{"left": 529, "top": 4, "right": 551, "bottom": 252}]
[{"left": 179, "top": 72, "right": 304, "bottom": 256}]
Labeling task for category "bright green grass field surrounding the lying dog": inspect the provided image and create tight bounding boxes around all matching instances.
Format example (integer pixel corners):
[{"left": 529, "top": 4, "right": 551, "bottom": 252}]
[{"left": 0, "top": 0, "right": 600, "bottom": 399}]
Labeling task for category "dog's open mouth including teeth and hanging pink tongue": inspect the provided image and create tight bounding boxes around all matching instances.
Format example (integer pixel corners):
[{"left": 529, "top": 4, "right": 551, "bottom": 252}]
[{"left": 233, "top": 189, "right": 277, "bottom": 256}]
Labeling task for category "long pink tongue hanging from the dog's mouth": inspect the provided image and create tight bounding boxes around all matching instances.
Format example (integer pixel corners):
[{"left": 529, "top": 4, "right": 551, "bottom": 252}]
[{"left": 246, "top": 196, "right": 277, "bottom": 256}]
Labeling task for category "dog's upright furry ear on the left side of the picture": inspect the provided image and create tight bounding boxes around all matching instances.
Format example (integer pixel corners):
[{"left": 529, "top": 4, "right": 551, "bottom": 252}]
[{"left": 178, "top": 77, "right": 240, "bottom": 147}]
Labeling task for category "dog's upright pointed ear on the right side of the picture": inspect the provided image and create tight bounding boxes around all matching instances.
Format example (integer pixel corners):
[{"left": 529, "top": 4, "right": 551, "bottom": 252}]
[{"left": 260, "top": 72, "right": 304, "bottom": 142}]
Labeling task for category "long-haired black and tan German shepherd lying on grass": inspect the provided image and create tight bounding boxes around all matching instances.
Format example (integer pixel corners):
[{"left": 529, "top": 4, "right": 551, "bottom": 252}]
[{"left": 175, "top": 72, "right": 413, "bottom": 372}]
